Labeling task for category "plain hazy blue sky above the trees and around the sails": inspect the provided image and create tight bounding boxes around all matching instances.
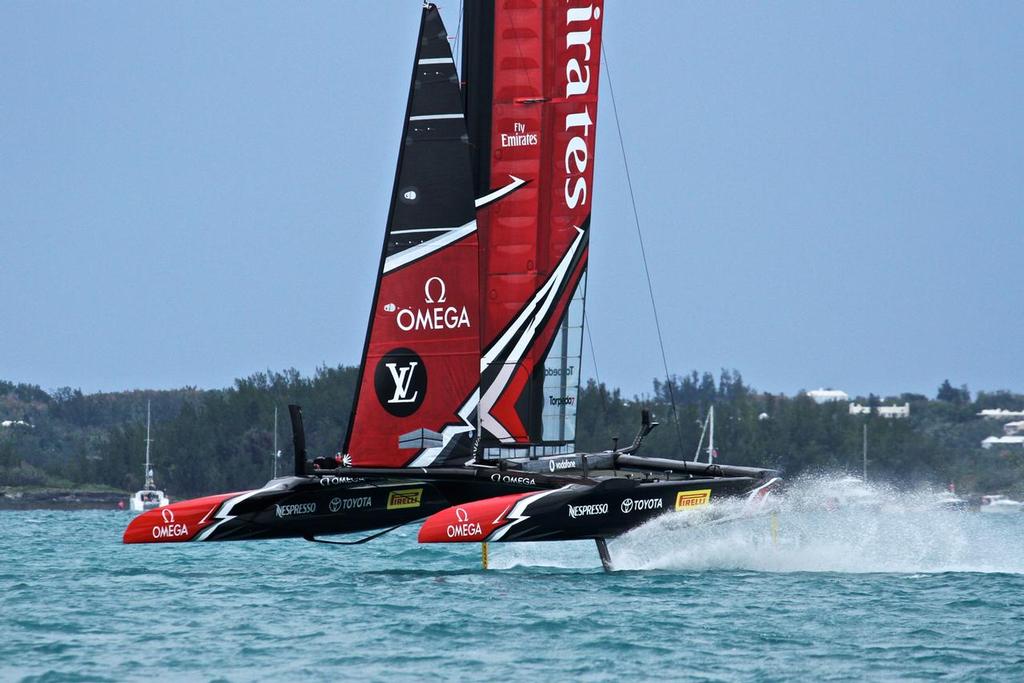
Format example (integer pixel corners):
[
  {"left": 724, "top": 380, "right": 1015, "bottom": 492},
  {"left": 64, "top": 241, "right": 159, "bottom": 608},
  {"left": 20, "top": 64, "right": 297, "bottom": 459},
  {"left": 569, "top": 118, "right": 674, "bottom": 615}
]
[{"left": 0, "top": 0, "right": 1024, "bottom": 395}]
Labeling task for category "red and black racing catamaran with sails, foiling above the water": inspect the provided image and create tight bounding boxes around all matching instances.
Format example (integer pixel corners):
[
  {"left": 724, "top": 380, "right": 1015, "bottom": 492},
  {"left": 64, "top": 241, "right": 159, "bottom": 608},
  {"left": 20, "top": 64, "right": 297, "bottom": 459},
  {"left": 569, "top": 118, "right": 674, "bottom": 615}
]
[{"left": 124, "top": 0, "right": 776, "bottom": 566}]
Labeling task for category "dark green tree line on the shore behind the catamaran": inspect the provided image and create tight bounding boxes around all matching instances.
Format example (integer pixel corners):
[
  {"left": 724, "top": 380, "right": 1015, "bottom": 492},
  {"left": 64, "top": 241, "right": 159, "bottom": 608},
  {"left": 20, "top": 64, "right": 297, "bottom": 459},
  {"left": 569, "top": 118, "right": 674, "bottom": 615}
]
[{"left": 0, "top": 366, "right": 1024, "bottom": 498}]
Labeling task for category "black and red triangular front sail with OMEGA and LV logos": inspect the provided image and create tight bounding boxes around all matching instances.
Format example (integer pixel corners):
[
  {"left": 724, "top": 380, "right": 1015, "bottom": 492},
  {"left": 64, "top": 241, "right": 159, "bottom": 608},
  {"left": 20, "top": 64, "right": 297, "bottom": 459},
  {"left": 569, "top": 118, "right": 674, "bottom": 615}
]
[{"left": 344, "top": 5, "right": 480, "bottom": 467}]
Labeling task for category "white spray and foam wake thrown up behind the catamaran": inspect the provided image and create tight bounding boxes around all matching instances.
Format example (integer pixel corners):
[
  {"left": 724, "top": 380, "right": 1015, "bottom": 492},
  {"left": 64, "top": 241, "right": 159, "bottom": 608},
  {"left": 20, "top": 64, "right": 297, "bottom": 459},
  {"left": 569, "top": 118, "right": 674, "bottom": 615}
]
[{"left": 492, "top": 477, "right": 1024, "bottom": 573}]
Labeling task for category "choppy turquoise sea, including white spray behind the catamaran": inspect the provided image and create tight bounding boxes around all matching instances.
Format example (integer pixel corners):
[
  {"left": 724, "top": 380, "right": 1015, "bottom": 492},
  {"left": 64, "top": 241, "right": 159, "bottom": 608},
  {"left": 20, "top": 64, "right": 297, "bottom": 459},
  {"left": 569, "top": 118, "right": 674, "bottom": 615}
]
[{"left": 0, "top": 479, "right": 1024, "bottom": 681}]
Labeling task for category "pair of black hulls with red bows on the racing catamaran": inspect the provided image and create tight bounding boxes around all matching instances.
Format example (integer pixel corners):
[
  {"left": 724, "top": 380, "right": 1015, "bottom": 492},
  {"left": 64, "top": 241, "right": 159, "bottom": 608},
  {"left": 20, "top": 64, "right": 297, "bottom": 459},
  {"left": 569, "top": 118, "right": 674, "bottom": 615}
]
[{"left": 124, "top": 461, "right": 772, "bottom": 543}]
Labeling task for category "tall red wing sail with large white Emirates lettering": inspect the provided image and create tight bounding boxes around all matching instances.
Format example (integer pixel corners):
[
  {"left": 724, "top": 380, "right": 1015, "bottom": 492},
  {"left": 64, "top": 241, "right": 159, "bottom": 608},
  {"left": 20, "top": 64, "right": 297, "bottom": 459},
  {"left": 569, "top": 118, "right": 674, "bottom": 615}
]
[{"left": 464, "top": 0, "right": 603, "bottom": 452}]
